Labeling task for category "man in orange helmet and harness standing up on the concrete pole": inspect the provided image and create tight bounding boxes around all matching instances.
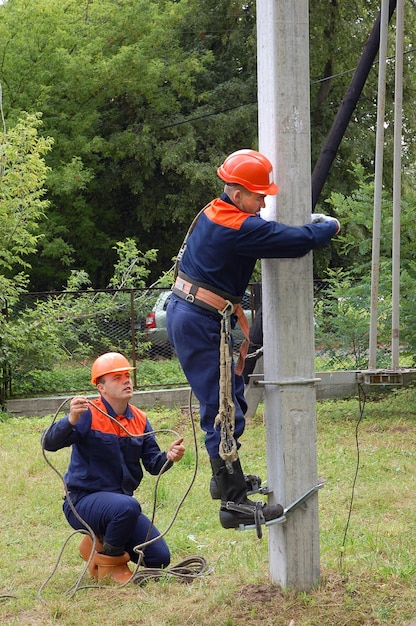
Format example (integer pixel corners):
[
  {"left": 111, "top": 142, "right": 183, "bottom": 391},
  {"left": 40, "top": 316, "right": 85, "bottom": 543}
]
[{"left": 167, "top": 150, "right": 340, "bottom": 528}]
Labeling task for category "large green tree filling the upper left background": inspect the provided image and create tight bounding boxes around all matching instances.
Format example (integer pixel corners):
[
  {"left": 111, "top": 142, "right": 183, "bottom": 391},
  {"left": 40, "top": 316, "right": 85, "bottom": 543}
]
[{"left": 0, "top": 0, "right": 211, "bottom": 287}]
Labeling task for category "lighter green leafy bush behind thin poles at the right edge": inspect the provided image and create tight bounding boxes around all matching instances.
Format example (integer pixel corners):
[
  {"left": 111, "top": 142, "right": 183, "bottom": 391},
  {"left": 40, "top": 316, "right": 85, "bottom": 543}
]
[{"left": 317, "top": 165, "right": 416, "bottom": 367}]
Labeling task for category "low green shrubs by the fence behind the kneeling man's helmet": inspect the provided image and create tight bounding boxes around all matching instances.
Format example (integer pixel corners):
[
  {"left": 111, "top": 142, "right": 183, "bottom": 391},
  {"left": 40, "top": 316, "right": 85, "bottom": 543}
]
[{"left": 0, "top": 240, "right": 156, "bottom": 395}]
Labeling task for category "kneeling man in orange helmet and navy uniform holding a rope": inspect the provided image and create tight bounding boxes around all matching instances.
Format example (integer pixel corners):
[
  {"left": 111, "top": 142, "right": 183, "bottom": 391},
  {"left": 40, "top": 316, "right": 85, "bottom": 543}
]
[{"left": 42, "top": 352, "right": 185, "bottom": 583}]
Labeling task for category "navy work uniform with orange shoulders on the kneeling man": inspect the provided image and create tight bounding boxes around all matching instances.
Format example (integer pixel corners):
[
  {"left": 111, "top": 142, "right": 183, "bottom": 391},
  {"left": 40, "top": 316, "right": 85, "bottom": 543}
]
[{"left": 42, "top": 397, "right": 172, "bottom": 567}]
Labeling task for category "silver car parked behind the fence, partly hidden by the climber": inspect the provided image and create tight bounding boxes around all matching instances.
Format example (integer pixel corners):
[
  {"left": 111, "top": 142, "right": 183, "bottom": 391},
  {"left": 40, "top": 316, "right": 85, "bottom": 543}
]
[{"left": 143, "top": 290, "right": 253, "bottom": 358}]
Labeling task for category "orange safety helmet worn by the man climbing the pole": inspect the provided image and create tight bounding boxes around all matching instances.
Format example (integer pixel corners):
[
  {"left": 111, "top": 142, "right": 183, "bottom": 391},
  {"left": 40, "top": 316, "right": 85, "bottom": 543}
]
[{"left": 217, "top": 150, "right": 279, "bottom": 196}]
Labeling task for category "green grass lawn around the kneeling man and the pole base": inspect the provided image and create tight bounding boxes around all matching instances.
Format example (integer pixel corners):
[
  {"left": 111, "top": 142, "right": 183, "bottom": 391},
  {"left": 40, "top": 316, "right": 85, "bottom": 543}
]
[{"left": 0, "top": 389, "right": 416, "bottom": 626}]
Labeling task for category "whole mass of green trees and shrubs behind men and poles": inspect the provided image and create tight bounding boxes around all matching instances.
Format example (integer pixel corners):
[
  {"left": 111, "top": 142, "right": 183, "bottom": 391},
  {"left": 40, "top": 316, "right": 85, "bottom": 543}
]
[{"left": 0, "top": 0, "right": 416, "bottom": 400}]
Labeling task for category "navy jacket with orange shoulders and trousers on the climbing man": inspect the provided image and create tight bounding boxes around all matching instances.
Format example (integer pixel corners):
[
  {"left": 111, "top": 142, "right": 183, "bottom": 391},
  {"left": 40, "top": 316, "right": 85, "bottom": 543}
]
[{"left": 167, "top": 194, "right": 338, "bottom": 459}]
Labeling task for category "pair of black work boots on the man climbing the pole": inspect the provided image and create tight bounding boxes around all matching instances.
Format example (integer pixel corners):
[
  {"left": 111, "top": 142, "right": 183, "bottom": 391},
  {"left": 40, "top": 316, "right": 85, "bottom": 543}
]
[{"left": 210, "top": 459, "right": 283, "bottom": 535}]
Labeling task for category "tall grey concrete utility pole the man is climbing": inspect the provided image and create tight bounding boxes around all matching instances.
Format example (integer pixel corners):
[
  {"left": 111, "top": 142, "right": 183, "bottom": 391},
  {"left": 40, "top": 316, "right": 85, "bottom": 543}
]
[{"left": 257, "top": 0, "right": 320, "bottom": 591}]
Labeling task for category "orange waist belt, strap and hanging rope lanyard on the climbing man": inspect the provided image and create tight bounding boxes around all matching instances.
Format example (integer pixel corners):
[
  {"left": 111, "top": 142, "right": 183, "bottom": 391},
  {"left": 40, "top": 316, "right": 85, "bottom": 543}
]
[{"left": 172, "top": 204, "right": 250, "bottom": 471}]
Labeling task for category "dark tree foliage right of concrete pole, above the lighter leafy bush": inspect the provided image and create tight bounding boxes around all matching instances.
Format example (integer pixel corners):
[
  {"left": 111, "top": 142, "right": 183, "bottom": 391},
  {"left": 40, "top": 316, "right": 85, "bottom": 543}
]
[{"left": 310, "top": 0, "right": 416, "bottom": 202}]
